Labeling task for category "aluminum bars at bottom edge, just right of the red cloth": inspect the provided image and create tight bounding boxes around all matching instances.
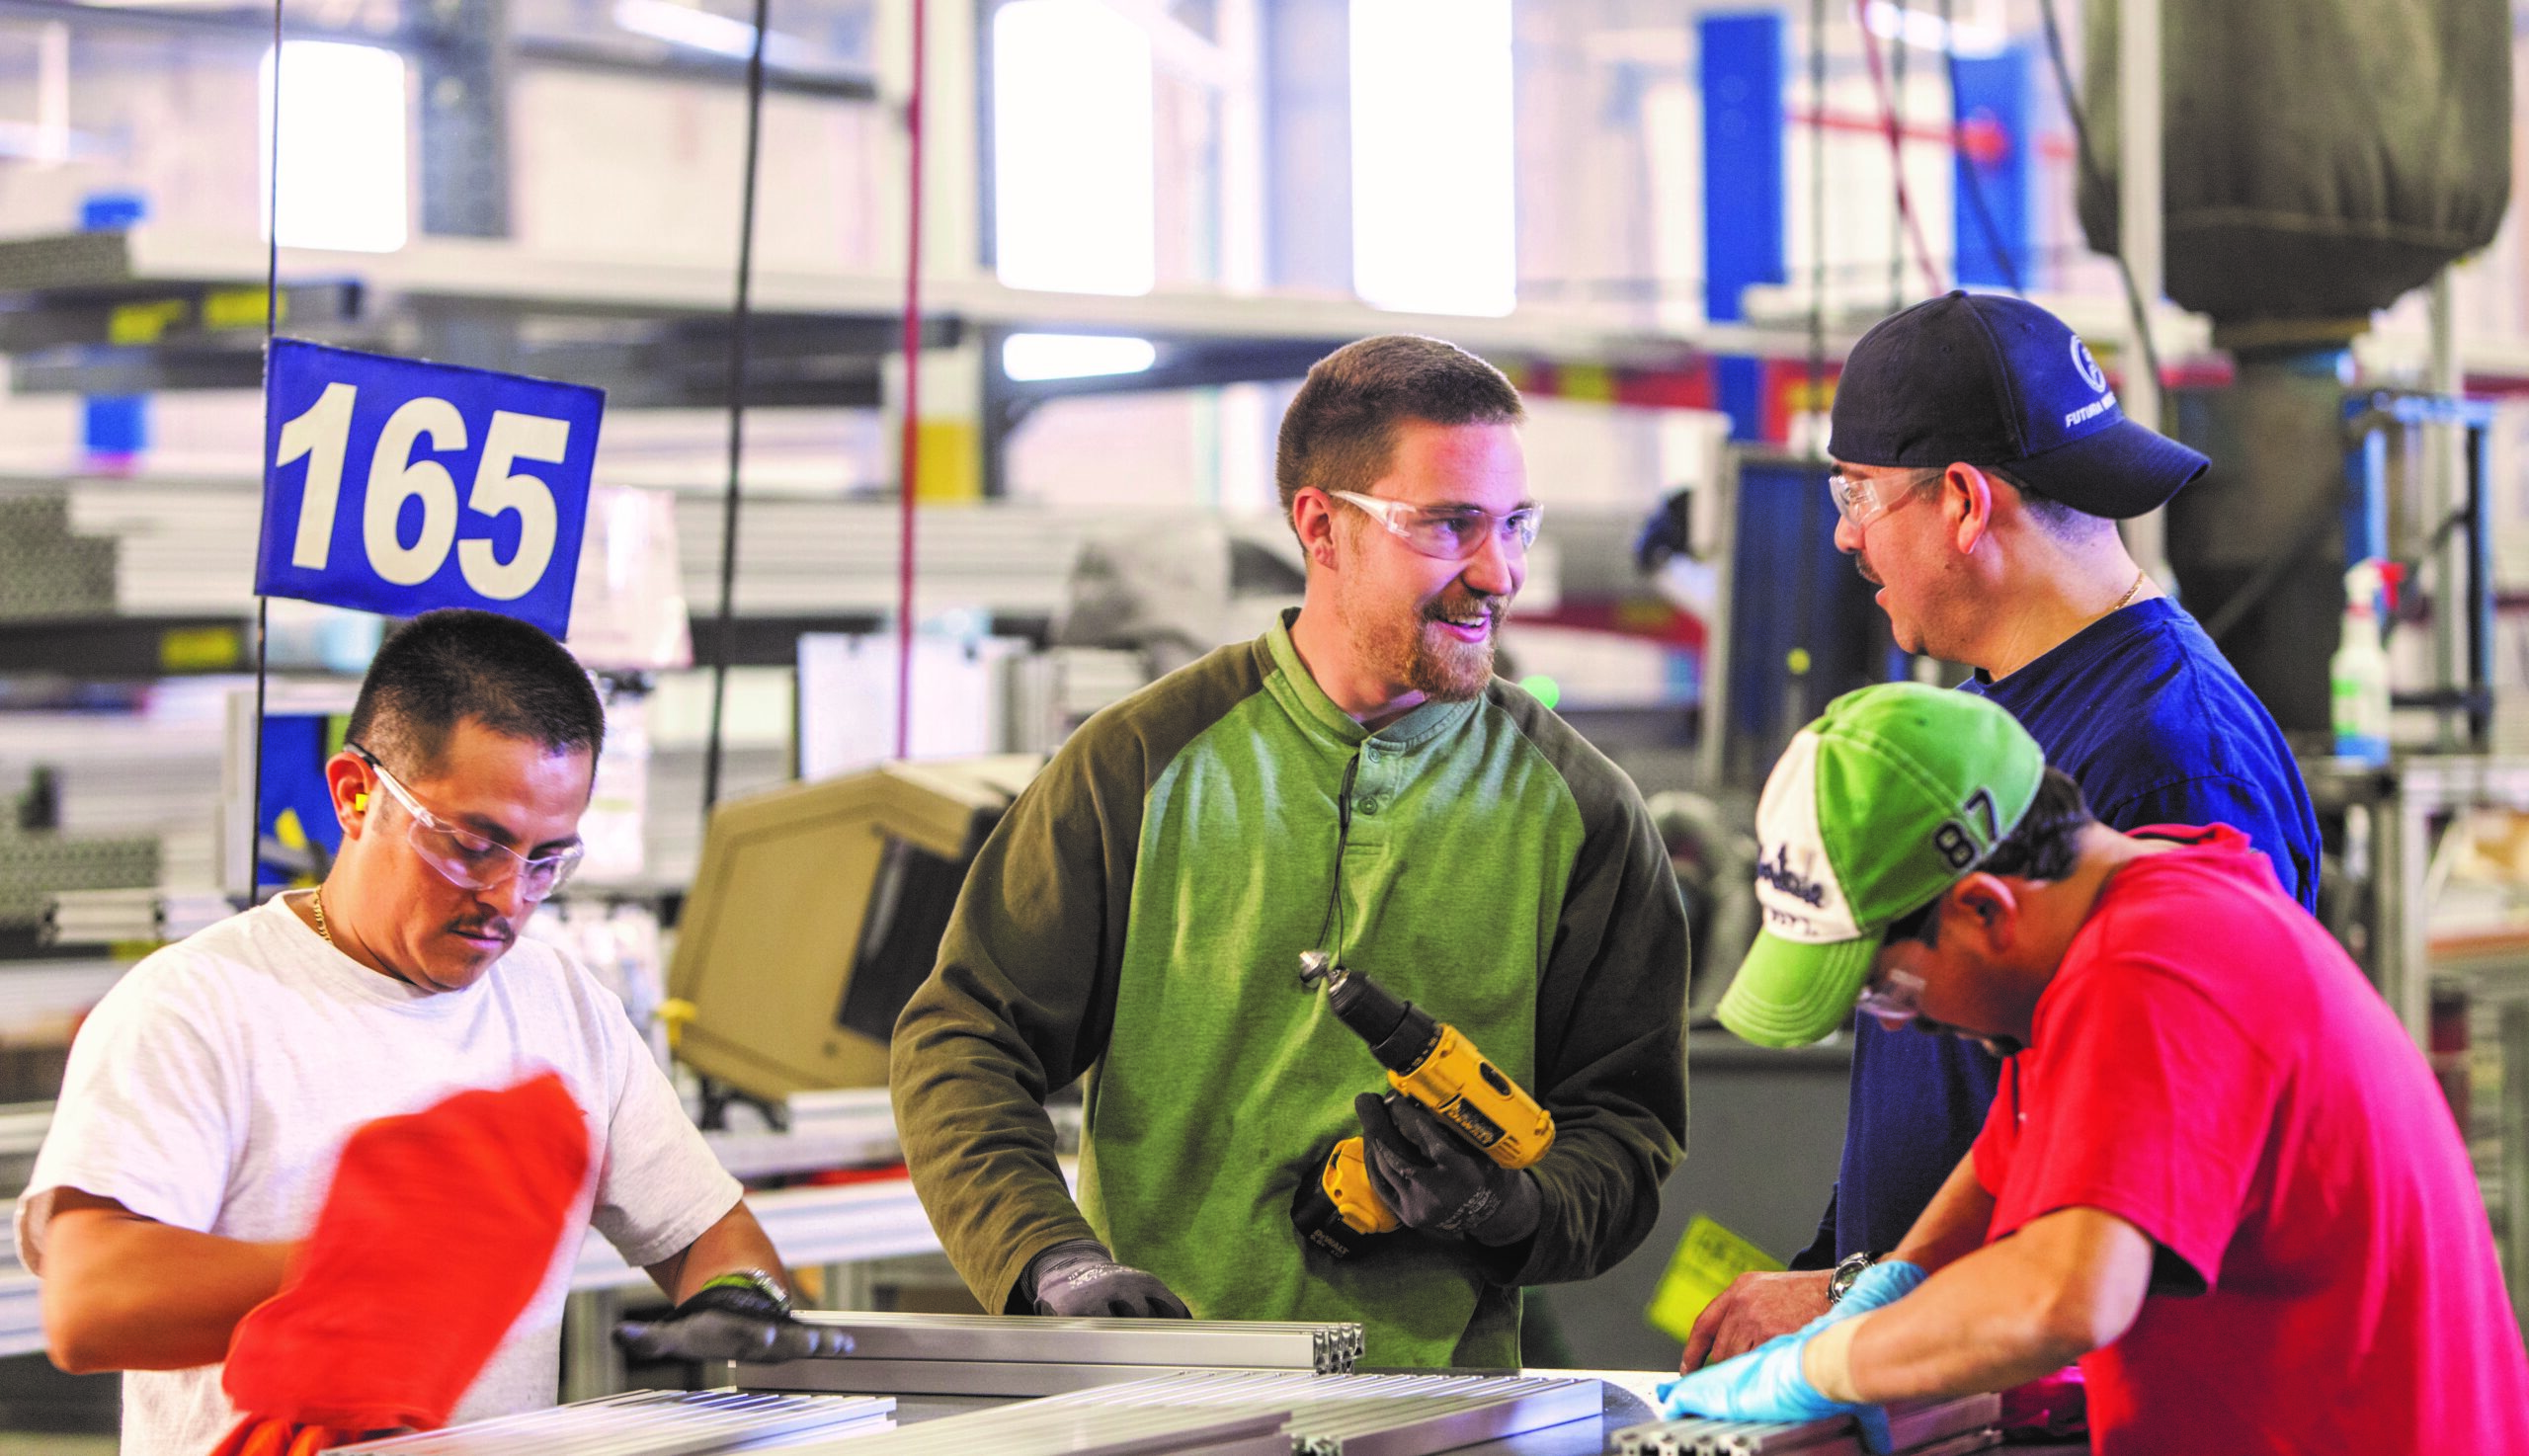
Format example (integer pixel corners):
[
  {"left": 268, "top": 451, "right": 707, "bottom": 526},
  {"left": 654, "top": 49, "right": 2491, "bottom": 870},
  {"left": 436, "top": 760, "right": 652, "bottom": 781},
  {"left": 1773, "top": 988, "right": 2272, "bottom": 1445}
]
[{"left": 334, "top": 1390, "right": 895, "bottom": 1456}]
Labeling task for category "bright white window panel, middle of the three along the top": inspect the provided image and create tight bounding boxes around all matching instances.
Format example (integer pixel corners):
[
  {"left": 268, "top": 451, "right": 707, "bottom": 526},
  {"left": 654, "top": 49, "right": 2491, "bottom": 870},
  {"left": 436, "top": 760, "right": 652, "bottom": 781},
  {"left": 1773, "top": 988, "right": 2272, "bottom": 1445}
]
[{"left": 992, "top": 0, "right": 1158, "bottom": 293}]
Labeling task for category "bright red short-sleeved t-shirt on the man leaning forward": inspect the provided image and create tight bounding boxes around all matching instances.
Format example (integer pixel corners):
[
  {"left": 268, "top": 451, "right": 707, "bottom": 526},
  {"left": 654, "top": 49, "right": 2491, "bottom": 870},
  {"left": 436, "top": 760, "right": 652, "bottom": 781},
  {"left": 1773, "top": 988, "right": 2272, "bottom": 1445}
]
[{"left": 1975, "top": 827, "right": 2529, "bottom": 1456}]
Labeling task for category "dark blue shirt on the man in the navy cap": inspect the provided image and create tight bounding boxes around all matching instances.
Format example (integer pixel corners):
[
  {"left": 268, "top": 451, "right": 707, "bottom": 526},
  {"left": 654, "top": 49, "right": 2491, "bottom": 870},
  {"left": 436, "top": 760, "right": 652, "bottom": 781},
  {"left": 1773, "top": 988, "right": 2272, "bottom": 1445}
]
[{"left": 1796, "top": 599, "right": 2320, "bottom": 1266}]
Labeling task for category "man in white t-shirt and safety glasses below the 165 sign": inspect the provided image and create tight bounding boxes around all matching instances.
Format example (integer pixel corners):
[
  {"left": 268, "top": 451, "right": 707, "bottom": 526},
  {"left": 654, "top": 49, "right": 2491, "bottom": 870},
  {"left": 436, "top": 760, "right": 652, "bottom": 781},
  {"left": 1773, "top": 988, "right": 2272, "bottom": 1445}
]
[{"left": 18, "top": 611, "right": 832, "bottom": 1456}]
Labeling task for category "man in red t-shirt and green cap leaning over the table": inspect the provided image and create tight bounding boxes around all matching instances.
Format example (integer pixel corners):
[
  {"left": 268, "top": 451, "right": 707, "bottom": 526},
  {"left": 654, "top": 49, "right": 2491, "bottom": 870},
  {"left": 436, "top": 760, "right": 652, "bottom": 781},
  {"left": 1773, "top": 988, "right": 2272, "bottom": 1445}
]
[{"left": 1662, "top": 685, "right": 2529, "bottom": 1456}]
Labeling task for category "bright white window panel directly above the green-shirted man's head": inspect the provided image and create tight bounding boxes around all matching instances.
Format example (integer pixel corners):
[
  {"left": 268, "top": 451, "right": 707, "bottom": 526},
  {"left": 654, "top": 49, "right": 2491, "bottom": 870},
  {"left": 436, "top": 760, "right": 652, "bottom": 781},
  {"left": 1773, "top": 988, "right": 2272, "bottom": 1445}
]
[{"left": 1353, "top": 0, "right": 1517, "bottom": 316}]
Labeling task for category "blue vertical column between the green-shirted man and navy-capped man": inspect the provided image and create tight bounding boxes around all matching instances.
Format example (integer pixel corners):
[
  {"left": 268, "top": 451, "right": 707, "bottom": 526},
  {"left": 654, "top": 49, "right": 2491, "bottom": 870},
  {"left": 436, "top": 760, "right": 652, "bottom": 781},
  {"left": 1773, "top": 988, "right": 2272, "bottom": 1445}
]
[{"left": 1697, "top": 10, "right": 1785, "bottom": 440}]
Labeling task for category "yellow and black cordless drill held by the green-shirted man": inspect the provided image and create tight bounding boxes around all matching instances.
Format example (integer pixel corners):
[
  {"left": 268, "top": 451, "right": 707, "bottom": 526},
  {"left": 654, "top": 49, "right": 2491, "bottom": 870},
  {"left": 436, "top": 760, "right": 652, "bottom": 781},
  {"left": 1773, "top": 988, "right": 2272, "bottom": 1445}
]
[{"left": 1290, "top": 950, "right": 1555, "bottom": 1258}]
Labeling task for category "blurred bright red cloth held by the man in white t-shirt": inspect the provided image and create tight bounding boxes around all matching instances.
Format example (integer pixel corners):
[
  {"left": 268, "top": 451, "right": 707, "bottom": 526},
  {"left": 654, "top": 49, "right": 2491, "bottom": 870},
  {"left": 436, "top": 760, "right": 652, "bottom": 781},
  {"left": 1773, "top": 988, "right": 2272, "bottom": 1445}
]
[{"left": 217, "top": 1072, "right": 589, "bottom": 1456}]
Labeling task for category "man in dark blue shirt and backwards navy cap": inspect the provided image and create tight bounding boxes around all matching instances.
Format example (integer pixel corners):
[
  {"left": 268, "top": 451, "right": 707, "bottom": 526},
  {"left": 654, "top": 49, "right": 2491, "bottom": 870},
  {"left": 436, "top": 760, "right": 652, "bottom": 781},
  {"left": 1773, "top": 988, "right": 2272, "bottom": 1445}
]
[{"left": 1681, "top": 293, "right": 2320, "bottom": 1370}]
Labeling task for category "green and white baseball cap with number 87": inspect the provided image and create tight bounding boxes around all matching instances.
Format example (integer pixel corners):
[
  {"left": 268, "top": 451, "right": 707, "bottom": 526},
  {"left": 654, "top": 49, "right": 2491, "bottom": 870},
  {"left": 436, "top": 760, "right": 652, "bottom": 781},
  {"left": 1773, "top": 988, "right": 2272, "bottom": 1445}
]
[{"left": 1720, "top": 683, "right": 2046, "bottom": 1046}]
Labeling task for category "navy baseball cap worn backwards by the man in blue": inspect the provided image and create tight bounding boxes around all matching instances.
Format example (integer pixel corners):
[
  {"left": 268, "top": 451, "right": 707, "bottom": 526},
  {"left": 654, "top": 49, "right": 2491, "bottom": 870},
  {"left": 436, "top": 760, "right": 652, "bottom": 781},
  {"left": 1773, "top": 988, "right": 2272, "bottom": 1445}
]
[{"left": 1826, "top": 293, "right": 2210, "bottom": 521}]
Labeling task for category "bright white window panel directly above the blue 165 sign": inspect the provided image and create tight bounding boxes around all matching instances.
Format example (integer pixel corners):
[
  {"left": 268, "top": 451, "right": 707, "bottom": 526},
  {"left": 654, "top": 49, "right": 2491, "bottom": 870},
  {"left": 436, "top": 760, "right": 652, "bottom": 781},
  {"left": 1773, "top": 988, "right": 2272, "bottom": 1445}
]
[{"left": 256, "top": 40, "right": 410, "bottom": 253}]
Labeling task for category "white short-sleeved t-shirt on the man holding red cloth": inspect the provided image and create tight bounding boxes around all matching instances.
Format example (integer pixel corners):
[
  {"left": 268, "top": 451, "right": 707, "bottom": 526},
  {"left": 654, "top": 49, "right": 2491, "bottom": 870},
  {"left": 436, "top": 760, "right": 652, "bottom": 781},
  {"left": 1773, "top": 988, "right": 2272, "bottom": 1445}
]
[{"left": 18, "top": 900, "right": 741, "bottom": 1456}]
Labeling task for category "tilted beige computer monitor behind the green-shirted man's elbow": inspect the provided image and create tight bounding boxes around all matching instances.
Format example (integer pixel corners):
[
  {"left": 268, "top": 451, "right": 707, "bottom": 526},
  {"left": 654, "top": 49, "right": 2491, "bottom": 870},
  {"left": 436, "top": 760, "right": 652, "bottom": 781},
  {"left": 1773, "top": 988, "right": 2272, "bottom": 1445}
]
[{"left": 668, "top": 754, "right": 1044, "bottom": 1099}]
